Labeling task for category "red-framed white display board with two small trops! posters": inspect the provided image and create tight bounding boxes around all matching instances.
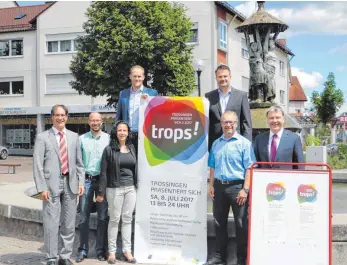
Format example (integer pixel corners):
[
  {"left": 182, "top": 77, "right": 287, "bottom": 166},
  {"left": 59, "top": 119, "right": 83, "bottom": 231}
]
[{"left": 248, "top": 169, "right": 331, "bottom": 265}]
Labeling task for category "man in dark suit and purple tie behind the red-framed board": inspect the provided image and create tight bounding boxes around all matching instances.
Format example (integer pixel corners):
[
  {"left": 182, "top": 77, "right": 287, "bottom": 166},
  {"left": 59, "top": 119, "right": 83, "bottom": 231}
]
[{"left": 254, "top": 106, "right": 304, "bottom": 169}]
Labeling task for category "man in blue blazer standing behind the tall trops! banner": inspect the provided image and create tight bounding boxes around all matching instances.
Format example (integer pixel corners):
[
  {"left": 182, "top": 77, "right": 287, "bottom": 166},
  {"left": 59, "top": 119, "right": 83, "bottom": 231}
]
[{"left": 115, "top": 65, "right": 158, "bottom": 154}]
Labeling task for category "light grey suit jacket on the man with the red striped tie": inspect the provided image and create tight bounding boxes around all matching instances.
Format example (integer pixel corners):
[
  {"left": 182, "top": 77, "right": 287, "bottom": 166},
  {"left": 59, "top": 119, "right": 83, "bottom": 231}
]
[{"left": 33, "top": 128, "right": 85, "bottom": 196}]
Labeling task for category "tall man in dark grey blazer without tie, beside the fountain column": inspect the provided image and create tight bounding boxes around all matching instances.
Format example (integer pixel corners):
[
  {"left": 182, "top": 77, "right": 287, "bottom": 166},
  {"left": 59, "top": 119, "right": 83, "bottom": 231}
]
[{"left": 205, "top": 65, "right": 252, "bottom": 150}]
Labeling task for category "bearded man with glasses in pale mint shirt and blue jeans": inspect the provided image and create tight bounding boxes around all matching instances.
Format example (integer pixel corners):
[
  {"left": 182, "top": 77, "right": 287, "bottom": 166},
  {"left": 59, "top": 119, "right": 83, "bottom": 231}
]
[{"left": 76, "top": 112, "right": 110, "bottom": 262}]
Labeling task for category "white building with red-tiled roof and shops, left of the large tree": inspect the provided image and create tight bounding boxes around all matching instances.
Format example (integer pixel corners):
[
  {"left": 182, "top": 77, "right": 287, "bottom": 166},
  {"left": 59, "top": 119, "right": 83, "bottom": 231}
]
[{"left": 0, "top": 2, "right": 115, "bottom": 154}]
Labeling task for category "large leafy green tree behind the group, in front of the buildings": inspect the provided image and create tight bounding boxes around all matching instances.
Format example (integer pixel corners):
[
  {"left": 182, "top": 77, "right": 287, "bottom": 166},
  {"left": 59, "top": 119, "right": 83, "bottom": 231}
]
[{"left": 70, "top": 1, "right": 195, "bottom": 104}]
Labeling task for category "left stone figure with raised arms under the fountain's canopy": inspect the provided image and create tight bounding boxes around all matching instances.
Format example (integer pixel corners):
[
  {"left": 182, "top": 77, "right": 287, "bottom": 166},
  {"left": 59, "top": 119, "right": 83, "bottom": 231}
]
[{"left": 245, "top": 28, "right": 266, "bottom": 103}]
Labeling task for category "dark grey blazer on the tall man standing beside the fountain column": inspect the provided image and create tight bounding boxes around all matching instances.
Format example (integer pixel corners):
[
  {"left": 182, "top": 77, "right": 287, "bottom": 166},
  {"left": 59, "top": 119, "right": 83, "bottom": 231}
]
[{"left": 205, "top": 87, "right": 252, "bottom": 150}]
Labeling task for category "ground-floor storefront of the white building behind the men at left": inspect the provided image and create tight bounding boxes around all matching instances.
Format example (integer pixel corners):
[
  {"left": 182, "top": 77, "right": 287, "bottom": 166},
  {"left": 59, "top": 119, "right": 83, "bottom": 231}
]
[{"left": 0, "top": 105, "right": 116, "bottom": 155}]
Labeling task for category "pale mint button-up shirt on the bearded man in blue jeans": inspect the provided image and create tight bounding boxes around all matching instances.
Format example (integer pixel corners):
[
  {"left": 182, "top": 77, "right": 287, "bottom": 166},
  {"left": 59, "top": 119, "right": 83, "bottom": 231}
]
[{"left": 80, "top": 131, "right": 110, "bottom": 176}]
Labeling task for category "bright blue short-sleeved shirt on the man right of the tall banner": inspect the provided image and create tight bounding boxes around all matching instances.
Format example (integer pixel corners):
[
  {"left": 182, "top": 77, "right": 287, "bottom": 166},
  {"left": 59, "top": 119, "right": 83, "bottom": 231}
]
[{"left": 208, "top": 132, "right": 256, "bottom": 181}]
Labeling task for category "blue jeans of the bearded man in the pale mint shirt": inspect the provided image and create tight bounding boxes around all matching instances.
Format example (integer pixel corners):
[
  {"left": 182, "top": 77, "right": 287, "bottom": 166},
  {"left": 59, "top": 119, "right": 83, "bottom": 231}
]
[{"left": 78, "top": 179, "right": 108, "bottom": 255}]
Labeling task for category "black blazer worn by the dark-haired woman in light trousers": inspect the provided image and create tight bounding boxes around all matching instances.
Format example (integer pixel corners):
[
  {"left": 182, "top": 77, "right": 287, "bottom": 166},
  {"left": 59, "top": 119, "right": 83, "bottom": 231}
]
[{"left": 98, "top": 144, "right": 137, "bottom": 196}]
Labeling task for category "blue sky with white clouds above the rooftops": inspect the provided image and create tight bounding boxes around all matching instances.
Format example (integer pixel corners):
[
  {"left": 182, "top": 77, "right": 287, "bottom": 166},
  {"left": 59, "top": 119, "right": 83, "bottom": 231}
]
[{"left": 18, "top": 1, "right": 347, "bottom": 113}]
